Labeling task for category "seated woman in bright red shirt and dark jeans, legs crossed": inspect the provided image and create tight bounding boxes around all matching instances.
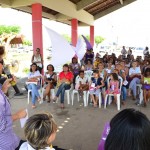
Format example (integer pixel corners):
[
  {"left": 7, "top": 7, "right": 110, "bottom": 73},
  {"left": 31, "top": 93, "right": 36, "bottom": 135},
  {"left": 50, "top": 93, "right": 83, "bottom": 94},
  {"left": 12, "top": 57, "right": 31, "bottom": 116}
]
[{"left": 53, "top": 64, "right": 73, "bottom": 109}]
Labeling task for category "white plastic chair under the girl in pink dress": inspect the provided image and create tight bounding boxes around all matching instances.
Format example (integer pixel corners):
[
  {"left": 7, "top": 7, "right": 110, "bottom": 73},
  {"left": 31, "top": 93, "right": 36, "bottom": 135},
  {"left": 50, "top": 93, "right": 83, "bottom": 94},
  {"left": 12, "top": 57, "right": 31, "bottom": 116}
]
[{"left": 104, "top": 76, "right": 123, "bottom": 111}]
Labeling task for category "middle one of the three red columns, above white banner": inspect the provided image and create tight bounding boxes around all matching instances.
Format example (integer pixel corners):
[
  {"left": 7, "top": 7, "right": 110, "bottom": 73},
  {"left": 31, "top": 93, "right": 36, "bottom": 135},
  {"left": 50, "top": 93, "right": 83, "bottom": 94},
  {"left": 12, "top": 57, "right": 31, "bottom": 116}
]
[{"left": 71, "top": 19, "right": 78, "bottom": 46}]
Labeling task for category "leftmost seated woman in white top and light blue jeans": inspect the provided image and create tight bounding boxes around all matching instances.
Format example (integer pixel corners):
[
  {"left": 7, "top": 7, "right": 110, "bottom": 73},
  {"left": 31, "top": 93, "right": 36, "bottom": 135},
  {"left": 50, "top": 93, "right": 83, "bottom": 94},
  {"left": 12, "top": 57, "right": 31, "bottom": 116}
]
[{"left": 27, "top": 63, "right": 41, "bottom": 108}]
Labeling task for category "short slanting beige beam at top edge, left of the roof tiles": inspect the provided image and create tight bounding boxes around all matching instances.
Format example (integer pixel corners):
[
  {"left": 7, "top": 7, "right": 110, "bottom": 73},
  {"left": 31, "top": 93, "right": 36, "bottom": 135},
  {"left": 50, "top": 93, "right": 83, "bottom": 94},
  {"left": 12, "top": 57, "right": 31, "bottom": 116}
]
[{"left": 77, "top": 0, "right": 98, "bottom": 10}]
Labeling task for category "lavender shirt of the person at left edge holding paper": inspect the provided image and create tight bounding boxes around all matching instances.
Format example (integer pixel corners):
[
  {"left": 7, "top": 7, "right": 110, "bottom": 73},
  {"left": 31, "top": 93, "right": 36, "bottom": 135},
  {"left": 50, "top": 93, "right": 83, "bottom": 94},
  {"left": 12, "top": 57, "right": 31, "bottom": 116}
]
[{"left": 0, "top": 90, "right": 20, "bottom": 150}]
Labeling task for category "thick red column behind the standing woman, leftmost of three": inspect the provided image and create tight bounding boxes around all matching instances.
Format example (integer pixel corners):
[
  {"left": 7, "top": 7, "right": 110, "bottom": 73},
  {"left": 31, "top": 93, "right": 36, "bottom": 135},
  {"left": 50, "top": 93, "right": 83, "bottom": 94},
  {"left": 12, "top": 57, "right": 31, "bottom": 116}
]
[{"left": 32, "top": 3, "right": 43, "bottom": 56}]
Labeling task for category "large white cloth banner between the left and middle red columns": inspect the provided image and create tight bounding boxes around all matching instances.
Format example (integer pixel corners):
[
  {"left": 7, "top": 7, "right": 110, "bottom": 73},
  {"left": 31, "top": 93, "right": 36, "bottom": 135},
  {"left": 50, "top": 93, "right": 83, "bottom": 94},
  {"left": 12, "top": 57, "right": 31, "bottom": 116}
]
[{"left": 44, "top": 26, "right": 75, "bottom": 67}]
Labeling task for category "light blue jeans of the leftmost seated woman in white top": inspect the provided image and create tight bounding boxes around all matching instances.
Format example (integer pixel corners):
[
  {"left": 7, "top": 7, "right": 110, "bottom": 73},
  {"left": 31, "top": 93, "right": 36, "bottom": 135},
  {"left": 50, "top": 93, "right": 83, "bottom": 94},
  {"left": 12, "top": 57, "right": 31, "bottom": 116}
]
[{"left": 27, "top": 84, "right": 40, "bottom": 105}]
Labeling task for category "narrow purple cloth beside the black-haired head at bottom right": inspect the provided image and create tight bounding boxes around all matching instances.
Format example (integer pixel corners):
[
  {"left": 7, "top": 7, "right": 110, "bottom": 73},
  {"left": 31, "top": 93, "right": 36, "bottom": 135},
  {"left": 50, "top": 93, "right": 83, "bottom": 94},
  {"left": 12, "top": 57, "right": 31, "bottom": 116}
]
[{"left": 98, "top": 122, "right": 110, "bottom": 150}]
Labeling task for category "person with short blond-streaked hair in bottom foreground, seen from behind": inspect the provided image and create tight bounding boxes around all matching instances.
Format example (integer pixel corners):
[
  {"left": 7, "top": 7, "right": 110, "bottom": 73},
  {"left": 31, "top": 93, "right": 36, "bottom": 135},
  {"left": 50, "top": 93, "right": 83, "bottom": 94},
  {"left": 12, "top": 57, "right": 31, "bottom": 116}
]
[{"left": 20, "top": 113, "right": 57, "bottom": 150}]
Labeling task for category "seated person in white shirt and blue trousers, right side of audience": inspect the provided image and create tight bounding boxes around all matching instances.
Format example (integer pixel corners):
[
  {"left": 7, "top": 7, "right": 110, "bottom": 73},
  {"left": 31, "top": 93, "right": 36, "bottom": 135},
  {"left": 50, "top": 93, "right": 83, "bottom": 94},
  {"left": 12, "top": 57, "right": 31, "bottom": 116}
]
[{"left": 128, "top": 61, "right": 141, "bottom": 100}]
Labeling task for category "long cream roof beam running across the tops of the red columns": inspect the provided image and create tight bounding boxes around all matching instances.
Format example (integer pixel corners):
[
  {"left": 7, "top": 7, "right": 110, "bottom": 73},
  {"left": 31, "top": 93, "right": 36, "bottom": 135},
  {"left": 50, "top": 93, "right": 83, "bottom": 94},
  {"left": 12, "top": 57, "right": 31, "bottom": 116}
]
[{"left": 11, "top": 0, "right": 94, "bottom": 25}]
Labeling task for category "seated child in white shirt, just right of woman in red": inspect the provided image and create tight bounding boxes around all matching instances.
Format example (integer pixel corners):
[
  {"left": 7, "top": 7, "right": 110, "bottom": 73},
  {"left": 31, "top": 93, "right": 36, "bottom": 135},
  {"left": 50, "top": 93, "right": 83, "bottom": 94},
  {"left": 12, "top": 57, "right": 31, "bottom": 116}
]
[{"left": 75, "top": 70, "right": 89, "bottom": 95}]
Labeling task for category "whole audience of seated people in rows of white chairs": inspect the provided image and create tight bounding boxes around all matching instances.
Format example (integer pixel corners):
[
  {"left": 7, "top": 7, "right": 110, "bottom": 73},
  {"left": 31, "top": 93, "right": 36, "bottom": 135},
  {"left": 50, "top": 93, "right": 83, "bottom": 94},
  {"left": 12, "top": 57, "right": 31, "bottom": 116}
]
[{"left": 28, "top": 49, "right": 150, "bottom": 108}]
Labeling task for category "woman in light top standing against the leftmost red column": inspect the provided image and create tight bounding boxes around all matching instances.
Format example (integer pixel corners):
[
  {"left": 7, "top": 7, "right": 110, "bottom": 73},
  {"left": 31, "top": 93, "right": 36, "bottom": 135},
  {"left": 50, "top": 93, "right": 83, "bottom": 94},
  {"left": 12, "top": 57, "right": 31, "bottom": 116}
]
[{"left": 31, "top": 48, "right": 43, "bottom": 73}]
